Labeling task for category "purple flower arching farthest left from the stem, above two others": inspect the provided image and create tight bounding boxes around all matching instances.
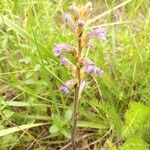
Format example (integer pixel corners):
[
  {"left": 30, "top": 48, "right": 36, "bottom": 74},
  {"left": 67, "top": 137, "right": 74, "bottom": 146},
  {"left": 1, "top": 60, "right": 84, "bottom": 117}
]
[{"left": 54, "top": 43, "right": 73, "bottom": 57}]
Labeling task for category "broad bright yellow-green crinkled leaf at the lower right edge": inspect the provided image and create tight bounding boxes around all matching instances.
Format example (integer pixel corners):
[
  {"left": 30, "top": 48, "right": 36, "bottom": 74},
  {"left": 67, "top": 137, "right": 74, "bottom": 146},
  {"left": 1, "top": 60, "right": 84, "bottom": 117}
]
[{"left": 122, "top": 102, "right": 150, "bottom": 137}]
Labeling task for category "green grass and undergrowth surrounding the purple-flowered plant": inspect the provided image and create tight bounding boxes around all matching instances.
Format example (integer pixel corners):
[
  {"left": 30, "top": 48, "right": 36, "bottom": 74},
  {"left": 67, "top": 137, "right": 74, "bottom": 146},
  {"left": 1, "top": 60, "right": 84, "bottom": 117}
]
[{"left": 0, "top": 0, "right": 150, "bottom": 150}]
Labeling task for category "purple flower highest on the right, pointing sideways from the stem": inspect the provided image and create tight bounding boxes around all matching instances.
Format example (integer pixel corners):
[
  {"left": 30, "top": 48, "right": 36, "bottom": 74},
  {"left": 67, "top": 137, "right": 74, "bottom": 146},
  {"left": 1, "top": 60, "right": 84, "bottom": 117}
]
[{"left": 88, "top": 28, "right": 107, "bottom": 41}]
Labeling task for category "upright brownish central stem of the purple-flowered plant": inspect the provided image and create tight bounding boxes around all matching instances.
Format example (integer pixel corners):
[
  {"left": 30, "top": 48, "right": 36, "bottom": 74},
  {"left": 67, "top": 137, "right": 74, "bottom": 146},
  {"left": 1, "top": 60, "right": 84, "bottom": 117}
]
[{"left": 71, "top": 33, "right": 82, "bottom": 150}]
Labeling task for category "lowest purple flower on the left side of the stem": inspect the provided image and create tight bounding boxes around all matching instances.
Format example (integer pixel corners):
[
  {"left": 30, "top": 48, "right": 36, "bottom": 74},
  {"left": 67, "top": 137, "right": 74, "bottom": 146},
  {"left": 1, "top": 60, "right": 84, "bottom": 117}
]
[{"left": 60, "top": 79, "right": 77, "bottom": 94}]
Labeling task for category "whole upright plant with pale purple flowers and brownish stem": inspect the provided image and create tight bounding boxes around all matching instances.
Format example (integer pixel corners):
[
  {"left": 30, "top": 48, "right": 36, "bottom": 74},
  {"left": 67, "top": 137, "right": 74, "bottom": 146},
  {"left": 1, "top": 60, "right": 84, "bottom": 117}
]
[{"left": 54, "top": 2, "right": 106, "bottom": 150}]
